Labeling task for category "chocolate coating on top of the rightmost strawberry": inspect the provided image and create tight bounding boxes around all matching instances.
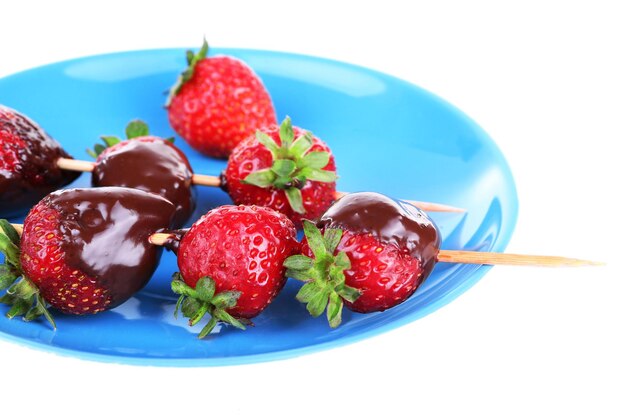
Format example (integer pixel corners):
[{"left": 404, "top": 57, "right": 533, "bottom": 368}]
[{"left": 318, "top": 192, "right": 441, "bottom": 277}]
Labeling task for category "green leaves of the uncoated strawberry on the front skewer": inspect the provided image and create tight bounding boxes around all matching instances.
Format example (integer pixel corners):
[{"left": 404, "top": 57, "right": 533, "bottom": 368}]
[{"left": 172, "top": 272, "right": 252, "bottom": 339}]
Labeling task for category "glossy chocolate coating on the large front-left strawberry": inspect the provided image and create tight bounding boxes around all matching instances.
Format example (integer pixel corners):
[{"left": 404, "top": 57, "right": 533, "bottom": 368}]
[{"left": 47, "top": 187, "right": 175, "bottom": 308}]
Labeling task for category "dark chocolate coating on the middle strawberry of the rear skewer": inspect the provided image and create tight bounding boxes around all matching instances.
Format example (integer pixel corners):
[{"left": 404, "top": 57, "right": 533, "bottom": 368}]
[{"left": 91, "top": 137, "right": 195, "bottom": 227}]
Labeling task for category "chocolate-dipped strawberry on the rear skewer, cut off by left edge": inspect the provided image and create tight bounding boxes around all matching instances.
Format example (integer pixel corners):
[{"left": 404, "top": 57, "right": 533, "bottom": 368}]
[{"left": 0, "top": 105, "right": 80, "bottom": 217}]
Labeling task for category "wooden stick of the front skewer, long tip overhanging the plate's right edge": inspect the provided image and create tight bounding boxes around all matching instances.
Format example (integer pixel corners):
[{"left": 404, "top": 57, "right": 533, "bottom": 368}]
[{"left": 0, "top": 224, "right": 604, "bottom": 267}]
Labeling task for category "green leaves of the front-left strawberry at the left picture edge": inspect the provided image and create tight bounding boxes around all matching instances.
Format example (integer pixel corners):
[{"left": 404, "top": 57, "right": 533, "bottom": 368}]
[{"left": 0, "top": 219, "right": 56, "bottom": 330}]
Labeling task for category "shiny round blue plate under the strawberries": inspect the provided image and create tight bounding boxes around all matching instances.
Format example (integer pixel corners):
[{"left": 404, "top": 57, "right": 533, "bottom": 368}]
[{"left": 0, "top": 49, "right": 517, "bottom": 366}]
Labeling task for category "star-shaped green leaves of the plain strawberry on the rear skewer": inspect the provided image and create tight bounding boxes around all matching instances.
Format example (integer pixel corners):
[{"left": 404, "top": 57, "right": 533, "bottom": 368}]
[{"left": 243, "top": 116, "right": 337, "bottom": 214}]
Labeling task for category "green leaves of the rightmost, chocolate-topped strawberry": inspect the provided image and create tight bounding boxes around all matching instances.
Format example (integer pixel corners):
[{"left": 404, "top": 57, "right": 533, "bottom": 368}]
[{"left": 283, "top": 220, "right": 361, "bottom": 328}]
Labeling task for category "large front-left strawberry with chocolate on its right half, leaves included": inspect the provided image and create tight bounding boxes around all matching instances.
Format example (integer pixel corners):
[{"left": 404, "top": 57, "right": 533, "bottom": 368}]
[{"left": 0, "top": 187, "right": 174, "bottom": 325}]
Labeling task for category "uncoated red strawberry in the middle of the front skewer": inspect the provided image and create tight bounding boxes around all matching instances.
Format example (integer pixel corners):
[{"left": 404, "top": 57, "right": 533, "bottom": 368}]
[{"left": 172, "top": 206, "right": 297, "bottom": 338}]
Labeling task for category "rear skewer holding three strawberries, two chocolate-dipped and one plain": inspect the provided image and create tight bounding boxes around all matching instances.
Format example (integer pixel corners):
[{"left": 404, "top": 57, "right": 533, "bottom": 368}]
[{"left": 0, "top": 106, "right": 462, "bottom": 227}]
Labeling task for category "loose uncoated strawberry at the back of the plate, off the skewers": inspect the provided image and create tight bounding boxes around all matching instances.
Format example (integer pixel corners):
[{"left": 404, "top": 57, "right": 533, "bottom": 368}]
[{"left": 165, "top": 40, "right": 276, "bottom": 158}]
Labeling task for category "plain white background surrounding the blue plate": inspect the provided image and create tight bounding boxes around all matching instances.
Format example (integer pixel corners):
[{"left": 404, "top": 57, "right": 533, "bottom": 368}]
[{"left": 0, "top": 0, "right": 626, "bottom": 416}]
